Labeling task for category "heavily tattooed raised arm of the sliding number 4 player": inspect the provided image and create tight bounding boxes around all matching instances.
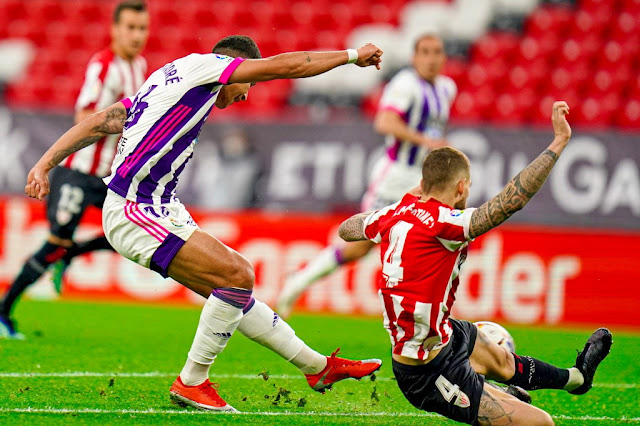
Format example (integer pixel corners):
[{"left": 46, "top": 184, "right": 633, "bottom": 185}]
[{"left": 469, "top": 102, "right": 571, "bottom": 238}]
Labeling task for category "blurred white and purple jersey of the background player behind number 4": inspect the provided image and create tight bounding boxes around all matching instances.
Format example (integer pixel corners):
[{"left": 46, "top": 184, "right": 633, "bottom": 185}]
[{"left": 379, "top": 68, "right": 458, "bottom": 167}]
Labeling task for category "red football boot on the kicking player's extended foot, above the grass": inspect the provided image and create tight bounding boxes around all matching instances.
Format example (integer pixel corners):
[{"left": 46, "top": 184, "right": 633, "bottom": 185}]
[{"left": 305, "top": 348, "right": 382, "bottom": 393}]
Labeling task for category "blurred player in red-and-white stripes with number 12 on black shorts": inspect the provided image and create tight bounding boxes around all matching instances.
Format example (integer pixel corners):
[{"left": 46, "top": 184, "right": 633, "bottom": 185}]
[{"left": 0, "top": 0, "right": 149, "bottom": 339}]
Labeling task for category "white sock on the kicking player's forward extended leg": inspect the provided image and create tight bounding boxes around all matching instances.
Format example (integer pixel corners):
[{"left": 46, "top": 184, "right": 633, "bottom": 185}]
[{"left": 238, "top": 300, "right": 327, "bottom": 374}]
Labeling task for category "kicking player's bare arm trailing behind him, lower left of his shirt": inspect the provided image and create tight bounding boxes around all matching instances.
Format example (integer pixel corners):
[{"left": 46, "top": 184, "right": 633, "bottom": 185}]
[{"left": 24, "top": 102, "right": 127, "bottom": 200}]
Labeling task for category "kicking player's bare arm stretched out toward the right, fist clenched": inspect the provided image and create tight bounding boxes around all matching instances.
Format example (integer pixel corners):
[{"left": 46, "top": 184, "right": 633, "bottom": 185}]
[{"left": 228, "top": 44, "right": 382, "bottom": 83}]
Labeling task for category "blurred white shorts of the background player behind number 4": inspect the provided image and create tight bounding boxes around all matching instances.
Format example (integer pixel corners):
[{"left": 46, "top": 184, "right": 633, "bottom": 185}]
[{"left": 360, "top": 155, "right": 422, "bottom": 212}]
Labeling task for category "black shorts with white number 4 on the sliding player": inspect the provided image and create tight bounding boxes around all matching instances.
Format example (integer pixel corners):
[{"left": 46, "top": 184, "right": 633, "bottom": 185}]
[{"left": 393, "top": 319, "right": 484, "bottom": 424}]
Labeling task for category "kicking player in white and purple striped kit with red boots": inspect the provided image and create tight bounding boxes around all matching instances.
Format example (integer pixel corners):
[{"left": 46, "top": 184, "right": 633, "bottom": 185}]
[{"left": 25, "top": 36, "right": 382, "bottom": 411}]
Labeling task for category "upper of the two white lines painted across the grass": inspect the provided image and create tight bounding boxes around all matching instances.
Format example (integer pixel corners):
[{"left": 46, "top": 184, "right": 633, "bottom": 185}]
[{"left": 0, "top": 371, "right": 640, "bottom": 389}]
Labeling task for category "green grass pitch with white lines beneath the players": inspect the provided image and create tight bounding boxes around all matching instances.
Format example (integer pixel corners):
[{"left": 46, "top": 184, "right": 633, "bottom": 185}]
[{"left": 0, "top": 301, "right": 640, "bottom": 425}]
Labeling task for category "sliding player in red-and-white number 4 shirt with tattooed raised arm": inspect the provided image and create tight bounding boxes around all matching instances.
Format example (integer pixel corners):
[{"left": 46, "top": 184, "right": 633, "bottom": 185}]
[{"left": 339, "top": 102, "right": 612, "bottom": 425}]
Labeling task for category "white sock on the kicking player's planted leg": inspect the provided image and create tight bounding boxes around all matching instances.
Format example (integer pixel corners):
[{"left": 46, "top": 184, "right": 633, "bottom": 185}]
[{"left": 180, "top": 295, "right": 242, "bottom": 386}]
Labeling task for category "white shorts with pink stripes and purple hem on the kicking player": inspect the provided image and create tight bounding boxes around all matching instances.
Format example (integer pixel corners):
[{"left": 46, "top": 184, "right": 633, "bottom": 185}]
[{"left": 102, "top": 190, "right": 198, "bottom": 278}]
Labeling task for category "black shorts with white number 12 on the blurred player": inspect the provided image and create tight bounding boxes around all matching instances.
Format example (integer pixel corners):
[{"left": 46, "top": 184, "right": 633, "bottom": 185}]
[{"left": 47, "top": 166, "right": 107, "bottom": 239}]
